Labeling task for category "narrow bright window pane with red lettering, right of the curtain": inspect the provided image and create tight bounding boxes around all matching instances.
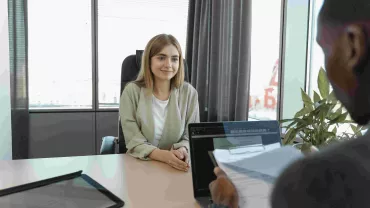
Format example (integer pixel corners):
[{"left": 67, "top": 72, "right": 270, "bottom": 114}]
[{"left": 249, "top": 0, "right": 281, "bottom": 120}]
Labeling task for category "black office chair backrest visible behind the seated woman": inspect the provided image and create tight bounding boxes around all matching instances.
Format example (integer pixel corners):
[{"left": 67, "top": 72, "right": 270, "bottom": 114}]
[{"left": 118, "top": 50, "right": 189, "bottom": 153}]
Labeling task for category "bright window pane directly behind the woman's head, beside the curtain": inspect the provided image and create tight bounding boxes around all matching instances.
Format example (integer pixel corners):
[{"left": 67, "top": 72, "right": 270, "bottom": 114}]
[{"left": 98, "top": 0, "right": 189, "bottom": 108}]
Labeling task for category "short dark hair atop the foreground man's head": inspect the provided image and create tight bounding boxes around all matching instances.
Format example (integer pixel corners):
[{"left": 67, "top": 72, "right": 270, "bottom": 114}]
[{"left": 319, "top": 0, "right": 370, "bottom": 25}]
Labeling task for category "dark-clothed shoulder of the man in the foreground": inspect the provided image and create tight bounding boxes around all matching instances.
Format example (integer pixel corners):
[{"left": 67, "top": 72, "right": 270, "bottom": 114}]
[{"left": 271, "top": 136, "right": 370, "bottom": 208}]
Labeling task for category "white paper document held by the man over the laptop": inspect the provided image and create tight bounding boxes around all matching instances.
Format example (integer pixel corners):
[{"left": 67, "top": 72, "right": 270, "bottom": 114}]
[{"left": 213, "top": 144, "right": 303, "bottom": 208}]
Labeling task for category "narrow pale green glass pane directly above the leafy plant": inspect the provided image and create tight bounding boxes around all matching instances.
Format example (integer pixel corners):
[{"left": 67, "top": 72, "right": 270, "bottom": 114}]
[{"left": 279, "top": 0, "right": 310, "bottom": 119}]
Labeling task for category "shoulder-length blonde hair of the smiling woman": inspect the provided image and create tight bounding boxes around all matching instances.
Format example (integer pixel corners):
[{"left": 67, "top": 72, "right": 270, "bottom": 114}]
[{"left": 134, "top": 34, "right": 185, "bottom": 89}]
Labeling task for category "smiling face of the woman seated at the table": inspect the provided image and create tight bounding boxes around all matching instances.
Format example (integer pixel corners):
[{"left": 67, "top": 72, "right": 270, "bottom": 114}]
[{"left": 150, "top": 44, "right": 180, "bottom": 81}]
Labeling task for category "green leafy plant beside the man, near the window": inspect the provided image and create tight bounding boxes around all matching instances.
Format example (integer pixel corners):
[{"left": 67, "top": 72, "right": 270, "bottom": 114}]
[{"left": 280, "top": 68, "right": 367, "bottom": 154}]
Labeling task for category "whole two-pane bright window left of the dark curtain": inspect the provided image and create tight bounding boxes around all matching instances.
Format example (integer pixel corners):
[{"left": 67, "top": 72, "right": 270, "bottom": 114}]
[{"left": 28, "top": 0, "right": 189, "bottom": 110}]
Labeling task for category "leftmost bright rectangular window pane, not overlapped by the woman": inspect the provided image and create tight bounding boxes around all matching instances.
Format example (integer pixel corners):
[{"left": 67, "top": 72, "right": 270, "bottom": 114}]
[{"left": 28, "top": 0, "right": 92, "bottom": 109}]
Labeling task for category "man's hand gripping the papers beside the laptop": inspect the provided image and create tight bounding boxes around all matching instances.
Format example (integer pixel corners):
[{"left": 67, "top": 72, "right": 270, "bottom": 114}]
[{"left": 209, "top": 167, "right": 239, "bottom": 208}]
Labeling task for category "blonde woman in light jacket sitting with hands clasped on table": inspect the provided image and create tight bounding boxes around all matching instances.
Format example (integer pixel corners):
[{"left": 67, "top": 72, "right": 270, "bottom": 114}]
[{"left": 119, "top": 34, "right": 199, "bottom": 171}]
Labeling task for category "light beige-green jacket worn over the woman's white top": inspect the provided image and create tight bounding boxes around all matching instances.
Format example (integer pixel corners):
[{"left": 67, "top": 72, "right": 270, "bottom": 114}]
[{"left": 119, "top": 82, "right": 199, "bottom": 160}]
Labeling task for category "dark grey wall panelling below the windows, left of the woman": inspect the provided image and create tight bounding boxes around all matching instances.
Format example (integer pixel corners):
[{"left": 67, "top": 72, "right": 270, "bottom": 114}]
[{"left": 28, "top": 112, "right": 118, "bottom": 158}]
